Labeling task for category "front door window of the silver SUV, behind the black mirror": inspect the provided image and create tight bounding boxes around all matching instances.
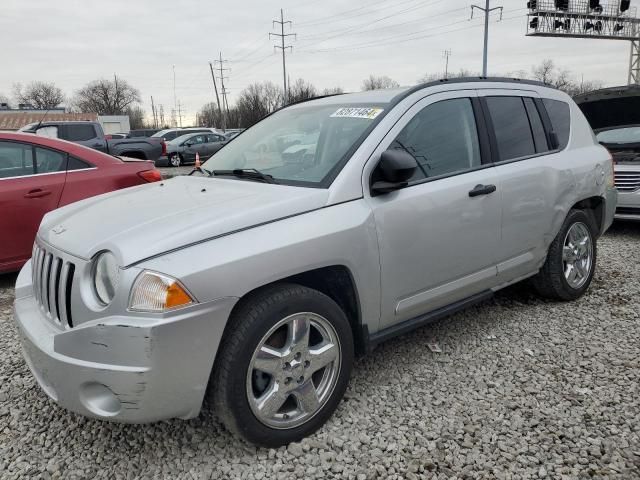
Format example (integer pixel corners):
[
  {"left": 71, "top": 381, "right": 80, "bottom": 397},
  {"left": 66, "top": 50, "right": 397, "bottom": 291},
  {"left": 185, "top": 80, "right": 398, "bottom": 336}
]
[{"left": 389, "top": 98, "right": 482, "bottom": 181}]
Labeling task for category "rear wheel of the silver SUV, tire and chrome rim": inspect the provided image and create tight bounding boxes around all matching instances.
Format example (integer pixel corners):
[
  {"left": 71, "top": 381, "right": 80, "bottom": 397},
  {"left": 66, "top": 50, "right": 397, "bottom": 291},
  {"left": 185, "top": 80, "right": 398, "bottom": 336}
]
[{"left": 532, "top": 210, "right": 597, "bottom": 301}]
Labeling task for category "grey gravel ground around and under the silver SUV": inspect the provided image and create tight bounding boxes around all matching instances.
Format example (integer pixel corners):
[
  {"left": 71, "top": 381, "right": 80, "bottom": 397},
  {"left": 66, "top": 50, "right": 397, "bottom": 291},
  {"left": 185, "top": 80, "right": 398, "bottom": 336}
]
[{"left": 0, "top": 224, "right": 640, "bottom": 480}]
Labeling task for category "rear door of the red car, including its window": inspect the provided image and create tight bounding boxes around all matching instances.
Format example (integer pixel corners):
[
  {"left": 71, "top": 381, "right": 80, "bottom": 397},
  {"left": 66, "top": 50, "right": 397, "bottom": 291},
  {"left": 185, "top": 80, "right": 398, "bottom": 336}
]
[{"left": 0, "top": 141, "right": 67, "bottom": 270}]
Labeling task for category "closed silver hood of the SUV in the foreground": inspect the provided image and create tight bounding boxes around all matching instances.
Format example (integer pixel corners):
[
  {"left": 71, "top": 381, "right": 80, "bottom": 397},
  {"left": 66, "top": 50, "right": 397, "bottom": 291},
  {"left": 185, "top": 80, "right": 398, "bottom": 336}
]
[{"left": 38, "top": 176, "right": 328, "bottom": 266}]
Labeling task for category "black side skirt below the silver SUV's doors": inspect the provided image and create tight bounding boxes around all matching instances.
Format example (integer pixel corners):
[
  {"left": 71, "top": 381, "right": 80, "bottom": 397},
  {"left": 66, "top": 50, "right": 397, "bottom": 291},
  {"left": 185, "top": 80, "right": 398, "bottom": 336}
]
[{"left": 362, "top": 290, "right": 493, "bottom": 352}]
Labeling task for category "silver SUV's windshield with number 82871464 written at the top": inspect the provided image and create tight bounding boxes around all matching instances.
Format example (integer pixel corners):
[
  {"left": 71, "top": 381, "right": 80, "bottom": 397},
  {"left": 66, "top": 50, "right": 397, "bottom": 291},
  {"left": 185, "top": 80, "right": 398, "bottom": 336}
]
[{"left": 202, "top": 104, "right": 385, "bottom": 186}]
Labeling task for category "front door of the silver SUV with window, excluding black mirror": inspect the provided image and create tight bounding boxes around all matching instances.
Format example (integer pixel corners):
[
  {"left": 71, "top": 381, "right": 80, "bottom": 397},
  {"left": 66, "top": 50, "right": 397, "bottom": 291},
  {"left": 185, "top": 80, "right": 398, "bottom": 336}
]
[{"left": 365, "top": 91, "right": 501, "bottom": 328}]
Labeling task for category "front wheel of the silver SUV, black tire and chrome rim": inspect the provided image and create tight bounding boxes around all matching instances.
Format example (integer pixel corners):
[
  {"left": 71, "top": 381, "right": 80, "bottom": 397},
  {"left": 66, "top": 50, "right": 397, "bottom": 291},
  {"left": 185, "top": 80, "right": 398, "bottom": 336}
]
[{"left": 208, "top": 284, "right": 354, "bottom": 447}]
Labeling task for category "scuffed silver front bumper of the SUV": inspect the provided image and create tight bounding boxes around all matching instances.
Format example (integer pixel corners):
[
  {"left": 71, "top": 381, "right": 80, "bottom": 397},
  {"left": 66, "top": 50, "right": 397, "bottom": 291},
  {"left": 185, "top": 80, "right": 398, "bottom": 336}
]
[{"left": 14, "top": 262, "right": 237, "bottom": 423}]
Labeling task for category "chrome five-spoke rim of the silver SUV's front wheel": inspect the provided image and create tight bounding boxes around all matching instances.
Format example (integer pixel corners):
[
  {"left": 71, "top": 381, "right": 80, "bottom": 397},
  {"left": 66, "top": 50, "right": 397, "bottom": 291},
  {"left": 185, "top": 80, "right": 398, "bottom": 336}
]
[{"left": 246, "top": 312, "right": 342, "bottom": 429}]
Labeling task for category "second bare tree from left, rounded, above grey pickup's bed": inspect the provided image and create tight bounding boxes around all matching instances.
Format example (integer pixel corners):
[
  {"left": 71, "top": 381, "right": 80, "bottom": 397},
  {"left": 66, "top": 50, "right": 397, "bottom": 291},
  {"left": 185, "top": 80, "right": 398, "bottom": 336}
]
[{"left": 73, "top": 77, "right": 140, "bottom": 115}]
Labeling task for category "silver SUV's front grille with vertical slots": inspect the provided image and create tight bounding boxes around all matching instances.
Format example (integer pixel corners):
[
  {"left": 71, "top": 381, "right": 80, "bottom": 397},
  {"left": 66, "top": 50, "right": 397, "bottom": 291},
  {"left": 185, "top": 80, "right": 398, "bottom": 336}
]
[{"left": 31, "top": 245, "right": 75, "bottom": 327}]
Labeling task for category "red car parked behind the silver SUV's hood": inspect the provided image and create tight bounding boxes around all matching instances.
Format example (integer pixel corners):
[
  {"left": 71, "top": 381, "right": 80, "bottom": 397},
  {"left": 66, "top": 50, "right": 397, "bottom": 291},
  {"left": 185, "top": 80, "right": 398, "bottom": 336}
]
[{"left": 0, "top": 132, "right": 162, "bottom": 273}]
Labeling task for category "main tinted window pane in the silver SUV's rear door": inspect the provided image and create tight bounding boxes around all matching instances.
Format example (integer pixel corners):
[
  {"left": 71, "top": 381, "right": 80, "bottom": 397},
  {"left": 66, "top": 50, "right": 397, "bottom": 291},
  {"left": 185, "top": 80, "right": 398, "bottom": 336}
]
[{"left": 486, "top": 97, "right": 536, "bottom": 161}]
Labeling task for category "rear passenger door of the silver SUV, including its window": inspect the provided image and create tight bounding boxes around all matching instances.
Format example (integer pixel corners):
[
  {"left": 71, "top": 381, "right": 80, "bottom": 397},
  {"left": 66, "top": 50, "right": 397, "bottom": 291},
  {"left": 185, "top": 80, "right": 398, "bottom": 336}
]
[{"left": 480, "top": 90, "right": 575, "bottom": 282}]
